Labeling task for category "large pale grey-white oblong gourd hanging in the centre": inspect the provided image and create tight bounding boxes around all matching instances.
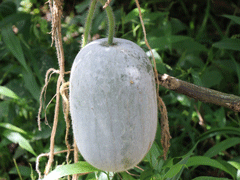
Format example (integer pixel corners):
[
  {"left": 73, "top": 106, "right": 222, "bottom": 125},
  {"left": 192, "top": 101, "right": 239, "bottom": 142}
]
[{"left": 70, "top": 38, "right": 157, "bottom": 172}]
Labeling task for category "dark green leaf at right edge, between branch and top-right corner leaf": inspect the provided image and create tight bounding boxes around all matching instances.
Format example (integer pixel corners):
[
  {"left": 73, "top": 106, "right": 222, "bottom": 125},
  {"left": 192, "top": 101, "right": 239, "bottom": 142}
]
[{"left": 212, "top": 39, "right": 240, "bottom": 51}]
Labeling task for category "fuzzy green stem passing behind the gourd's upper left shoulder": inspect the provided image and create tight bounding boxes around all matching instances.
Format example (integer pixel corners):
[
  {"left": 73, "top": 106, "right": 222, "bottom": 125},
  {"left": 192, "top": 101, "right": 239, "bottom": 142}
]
[{"left": 82, "top": 0, "right": 97, "bottom": 47}]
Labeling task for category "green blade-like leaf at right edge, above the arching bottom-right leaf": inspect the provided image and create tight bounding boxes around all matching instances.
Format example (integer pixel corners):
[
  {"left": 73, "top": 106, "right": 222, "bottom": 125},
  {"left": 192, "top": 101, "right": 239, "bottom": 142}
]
[{"left": 204, "top": 138, "right": 240, "bottom": 158}]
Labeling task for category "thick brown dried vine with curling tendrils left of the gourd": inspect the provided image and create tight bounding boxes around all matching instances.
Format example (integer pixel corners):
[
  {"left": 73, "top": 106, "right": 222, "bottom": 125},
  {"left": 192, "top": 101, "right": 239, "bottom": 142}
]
[{"left": 36, "top": 0, "right": 70, "bottom": 175}]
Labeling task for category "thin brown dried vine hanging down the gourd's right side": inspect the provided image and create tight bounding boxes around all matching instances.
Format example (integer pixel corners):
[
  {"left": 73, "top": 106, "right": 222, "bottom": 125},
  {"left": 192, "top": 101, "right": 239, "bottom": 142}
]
[{"left": 135, "top": 0, "right": 171, "bottom": 160}]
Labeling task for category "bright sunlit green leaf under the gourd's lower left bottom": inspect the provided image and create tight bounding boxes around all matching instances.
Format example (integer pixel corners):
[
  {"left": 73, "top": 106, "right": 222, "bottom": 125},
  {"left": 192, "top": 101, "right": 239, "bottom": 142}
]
[{"left": 43, "top": 161, "right": 99, "bottom": 180}]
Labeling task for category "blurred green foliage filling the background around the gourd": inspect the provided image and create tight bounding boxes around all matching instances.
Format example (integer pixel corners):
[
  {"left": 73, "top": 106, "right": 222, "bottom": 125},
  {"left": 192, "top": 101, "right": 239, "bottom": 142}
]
[{"left": 0, "top": 0, "right": 240, "bottom": 180}]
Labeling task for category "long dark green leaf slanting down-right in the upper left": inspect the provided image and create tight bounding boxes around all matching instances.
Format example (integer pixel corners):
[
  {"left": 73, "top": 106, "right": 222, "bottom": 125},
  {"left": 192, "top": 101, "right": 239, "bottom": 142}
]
[{"left": 1, "top": 26, "right": 29, "bottom": 71}]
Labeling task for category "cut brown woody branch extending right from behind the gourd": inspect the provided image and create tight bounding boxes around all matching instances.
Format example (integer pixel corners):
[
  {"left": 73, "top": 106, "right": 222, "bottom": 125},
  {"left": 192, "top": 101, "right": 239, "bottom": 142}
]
[{"left": 158, "top": 74, "right": 240, "bottom": 112}]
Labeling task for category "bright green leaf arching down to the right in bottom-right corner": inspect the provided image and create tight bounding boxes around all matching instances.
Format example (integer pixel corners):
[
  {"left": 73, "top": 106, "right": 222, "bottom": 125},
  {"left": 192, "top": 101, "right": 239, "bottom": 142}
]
[{"left": 186, "top": 156, "right": 235, "bottom": 177}]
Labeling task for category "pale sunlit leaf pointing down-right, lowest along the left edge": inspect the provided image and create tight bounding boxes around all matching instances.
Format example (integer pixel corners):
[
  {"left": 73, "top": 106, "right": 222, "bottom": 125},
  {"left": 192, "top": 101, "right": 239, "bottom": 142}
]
[{"left": 2, "top": 130, "right": 37, "bottom": 156}]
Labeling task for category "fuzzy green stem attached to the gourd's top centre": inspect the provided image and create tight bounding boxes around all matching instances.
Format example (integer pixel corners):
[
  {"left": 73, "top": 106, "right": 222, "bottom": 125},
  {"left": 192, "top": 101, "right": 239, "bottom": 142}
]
[{"left": 99, "top": 0, "right": 115, "bottom": 45}]
